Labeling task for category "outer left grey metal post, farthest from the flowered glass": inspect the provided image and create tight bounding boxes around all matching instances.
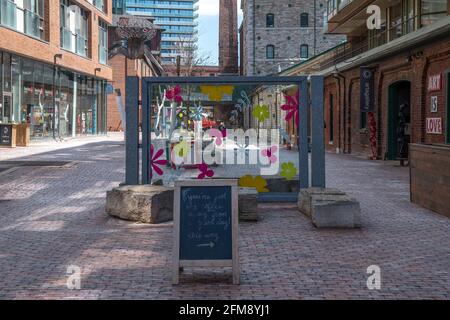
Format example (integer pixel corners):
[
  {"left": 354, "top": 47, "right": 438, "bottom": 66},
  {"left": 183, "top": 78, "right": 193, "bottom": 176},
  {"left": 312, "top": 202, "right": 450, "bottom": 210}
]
[{"left": 125, "top": 77, "right": 139, "bottom": 185}]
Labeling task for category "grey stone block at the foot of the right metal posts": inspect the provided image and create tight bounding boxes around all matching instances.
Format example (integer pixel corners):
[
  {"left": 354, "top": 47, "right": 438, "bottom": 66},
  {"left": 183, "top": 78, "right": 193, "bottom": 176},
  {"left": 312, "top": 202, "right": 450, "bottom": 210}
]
[{"left": 298, "top": 188, "right": 361, "bottom": 228}]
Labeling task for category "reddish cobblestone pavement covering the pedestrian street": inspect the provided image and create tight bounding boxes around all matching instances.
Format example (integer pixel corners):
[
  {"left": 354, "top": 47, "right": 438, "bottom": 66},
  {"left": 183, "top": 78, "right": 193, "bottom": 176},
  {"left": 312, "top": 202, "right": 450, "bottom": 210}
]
[{"left": 0, "top": 138, "right": 450, "bottom": 299}]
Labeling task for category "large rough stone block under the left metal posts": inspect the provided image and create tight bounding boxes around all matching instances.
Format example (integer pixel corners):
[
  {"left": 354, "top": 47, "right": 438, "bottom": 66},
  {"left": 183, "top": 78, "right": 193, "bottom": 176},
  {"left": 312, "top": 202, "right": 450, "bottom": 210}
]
[{"left": 106, "top": 185, "right": 174, "bottom": 224}]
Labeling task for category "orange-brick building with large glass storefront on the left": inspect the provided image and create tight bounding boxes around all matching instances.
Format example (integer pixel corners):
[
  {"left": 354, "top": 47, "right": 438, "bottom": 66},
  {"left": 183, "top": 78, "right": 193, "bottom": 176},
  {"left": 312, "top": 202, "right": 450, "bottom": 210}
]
[{"left": 0, "top": 0, "right": 112, "bottom": 139}]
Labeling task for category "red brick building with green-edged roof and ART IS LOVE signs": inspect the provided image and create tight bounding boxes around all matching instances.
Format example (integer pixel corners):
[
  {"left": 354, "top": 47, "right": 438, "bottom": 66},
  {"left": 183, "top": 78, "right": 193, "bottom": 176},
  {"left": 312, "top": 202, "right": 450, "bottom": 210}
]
[{"left": 281, "top": 0, "right": 450, "bottom": 160}]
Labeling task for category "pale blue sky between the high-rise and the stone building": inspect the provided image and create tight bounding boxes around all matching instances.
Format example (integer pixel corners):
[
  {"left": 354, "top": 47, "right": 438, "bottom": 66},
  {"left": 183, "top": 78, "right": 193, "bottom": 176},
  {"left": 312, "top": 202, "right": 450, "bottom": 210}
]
[{"left": 198, "top": 0, "right": 242, "bottom": 65}]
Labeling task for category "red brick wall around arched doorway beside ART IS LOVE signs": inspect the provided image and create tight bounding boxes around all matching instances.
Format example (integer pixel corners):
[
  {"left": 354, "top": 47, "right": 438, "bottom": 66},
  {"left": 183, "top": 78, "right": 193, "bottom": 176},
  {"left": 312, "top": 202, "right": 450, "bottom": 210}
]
[{"left": 324, "top": 38, "right": 450, "bottom": 159}]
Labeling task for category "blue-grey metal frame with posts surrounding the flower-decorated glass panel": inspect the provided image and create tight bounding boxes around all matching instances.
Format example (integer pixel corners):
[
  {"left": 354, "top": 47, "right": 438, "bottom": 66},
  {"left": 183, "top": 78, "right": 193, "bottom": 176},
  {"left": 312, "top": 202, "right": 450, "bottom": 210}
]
[{"left": 125, "top": 76, "right": 325, "bottom": 201}]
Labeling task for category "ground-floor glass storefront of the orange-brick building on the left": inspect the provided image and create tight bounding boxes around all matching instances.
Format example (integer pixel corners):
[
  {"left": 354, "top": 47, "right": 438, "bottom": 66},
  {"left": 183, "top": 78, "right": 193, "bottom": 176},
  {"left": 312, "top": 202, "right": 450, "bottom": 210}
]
[{"left": 0, "top": 52, "right": 106, "bottom": 139}]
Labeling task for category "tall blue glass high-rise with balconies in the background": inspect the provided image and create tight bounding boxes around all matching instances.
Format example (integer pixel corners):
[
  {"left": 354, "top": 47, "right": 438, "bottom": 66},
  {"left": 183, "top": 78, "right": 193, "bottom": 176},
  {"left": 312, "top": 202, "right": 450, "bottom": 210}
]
[{"left": 113, "top": 0, "right": 198, "bottom": 64}]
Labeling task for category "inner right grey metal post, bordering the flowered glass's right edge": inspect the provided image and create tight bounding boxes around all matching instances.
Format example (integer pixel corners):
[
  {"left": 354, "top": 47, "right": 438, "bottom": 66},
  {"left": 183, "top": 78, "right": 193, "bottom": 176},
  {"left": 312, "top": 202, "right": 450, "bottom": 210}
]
[{"left": 297, "top": 78, "right": 309, "bottom": 189}]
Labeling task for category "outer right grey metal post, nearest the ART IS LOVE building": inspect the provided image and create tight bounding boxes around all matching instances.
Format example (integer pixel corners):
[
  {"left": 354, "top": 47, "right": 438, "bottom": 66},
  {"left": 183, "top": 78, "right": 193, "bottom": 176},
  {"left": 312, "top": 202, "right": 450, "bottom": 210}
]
[{"left": 311, "top": 76, "right": 325, "bottom": 188}]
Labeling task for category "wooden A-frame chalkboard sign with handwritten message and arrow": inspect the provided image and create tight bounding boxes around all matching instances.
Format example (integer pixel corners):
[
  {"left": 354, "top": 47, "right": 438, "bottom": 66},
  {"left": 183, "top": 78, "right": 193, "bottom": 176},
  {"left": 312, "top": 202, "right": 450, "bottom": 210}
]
[{"left": 173, "top": 179, "right": 239, "bottom": 284}]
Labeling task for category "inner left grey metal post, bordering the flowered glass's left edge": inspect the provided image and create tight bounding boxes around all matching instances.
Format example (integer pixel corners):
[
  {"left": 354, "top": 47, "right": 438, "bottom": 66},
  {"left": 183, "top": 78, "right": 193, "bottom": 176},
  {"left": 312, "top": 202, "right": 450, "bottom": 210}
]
[{"left": 141, "top": 79, "right": 152, "bottom": 184}]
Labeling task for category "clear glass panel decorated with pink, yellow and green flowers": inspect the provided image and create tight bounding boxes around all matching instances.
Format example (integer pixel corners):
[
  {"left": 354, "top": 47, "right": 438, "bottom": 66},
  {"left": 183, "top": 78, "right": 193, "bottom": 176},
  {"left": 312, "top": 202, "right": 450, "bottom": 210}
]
[{"left": 149, "top": 84, "right": 299, "bottom": 198}]
